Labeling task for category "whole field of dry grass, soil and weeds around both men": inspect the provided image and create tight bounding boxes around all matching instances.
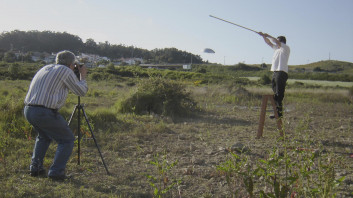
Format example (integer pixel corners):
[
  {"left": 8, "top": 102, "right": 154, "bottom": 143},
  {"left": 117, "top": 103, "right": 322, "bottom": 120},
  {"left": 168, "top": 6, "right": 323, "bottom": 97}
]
[{"left": 0, "top": 65, "right": 353, "bottom": 197}]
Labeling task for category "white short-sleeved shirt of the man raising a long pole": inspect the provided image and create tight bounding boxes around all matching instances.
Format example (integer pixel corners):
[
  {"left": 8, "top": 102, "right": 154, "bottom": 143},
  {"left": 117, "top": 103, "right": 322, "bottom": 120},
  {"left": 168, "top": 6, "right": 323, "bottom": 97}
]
[{"left": 271, "top": 43, "right": 290, "bottom": 73}]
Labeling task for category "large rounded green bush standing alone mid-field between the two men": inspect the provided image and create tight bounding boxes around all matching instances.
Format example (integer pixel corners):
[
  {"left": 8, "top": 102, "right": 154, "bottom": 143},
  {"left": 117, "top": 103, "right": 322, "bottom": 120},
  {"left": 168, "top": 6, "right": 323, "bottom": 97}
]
[{"left": 118, "top": 77, "right": 196, "bottom": 116}]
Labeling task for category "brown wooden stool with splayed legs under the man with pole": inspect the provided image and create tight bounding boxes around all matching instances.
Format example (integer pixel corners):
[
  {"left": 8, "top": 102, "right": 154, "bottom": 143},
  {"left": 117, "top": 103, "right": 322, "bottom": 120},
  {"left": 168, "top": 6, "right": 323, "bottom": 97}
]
[{"left": 257, "top": 95, "right": 283, "bottom": 138}]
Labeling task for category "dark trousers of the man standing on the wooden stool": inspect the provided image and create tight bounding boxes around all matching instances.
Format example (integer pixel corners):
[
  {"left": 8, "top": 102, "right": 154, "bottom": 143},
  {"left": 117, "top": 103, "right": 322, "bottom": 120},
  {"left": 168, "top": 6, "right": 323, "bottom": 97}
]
[{"left": 272, "top": 71, "right": 288, "bottom": 117}]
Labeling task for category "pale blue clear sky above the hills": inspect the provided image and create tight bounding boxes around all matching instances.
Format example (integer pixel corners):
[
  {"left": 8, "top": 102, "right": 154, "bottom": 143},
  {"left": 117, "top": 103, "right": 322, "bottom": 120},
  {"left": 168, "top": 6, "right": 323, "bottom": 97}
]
[{"left": 0, "top": 0, "right": 353, "bottom": 65}]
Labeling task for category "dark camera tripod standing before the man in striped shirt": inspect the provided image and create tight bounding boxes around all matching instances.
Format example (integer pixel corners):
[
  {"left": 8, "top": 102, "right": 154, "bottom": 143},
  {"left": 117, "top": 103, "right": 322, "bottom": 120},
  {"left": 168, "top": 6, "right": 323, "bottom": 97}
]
[{"left": 69, "top": 96, "right": 110, "bottom": 175}]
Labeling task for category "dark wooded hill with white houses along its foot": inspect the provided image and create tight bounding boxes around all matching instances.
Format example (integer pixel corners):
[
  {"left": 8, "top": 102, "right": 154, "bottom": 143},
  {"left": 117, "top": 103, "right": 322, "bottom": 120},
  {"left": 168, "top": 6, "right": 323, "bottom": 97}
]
[{"left": 0, "top": 30, "right": 203, "bottom": 64}]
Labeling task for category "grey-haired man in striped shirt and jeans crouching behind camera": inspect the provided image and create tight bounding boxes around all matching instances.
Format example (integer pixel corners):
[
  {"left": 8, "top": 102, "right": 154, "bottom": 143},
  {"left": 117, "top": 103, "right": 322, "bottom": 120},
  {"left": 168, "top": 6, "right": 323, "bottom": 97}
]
[{"left": 24, "top": 51, "right": 88, "bottom": 180}]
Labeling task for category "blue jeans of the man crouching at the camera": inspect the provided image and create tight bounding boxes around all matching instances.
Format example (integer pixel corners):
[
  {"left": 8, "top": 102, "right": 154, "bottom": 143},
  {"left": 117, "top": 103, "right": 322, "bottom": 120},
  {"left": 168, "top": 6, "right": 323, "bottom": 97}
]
[{"left": 24, "top": 106, "right": 75, "bottom": 176}]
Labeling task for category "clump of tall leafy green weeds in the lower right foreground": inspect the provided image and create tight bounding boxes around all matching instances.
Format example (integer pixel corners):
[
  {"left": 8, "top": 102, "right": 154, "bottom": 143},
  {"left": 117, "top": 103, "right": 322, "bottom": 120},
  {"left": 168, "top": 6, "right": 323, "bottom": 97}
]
[{"left": 218, "top": 116, "right": 345, "bottom": 198}]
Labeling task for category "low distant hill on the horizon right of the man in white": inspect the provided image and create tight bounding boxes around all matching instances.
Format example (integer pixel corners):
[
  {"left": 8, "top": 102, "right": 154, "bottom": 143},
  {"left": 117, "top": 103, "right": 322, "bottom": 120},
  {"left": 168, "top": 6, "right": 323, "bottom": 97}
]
[{"left": 289, "top": 60, "right": 353, "bottom": 73}]
